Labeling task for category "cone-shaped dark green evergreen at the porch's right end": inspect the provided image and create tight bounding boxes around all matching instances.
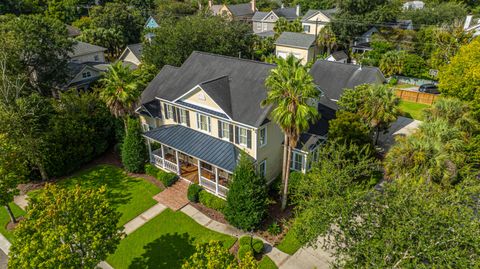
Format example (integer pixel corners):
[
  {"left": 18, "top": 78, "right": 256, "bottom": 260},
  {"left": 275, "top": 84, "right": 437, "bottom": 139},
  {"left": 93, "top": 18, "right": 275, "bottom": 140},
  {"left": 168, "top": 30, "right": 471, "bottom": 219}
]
[{"left": 225, "top": 154, "right": 268, "bottom": 231}]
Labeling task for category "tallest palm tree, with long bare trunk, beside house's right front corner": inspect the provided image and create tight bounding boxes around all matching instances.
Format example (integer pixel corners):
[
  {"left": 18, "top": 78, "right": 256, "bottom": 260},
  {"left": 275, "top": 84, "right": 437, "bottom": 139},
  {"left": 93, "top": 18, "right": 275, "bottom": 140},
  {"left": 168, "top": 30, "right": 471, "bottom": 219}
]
[{"left": 262, "top": 55, "right": 320, "bottom": 210}]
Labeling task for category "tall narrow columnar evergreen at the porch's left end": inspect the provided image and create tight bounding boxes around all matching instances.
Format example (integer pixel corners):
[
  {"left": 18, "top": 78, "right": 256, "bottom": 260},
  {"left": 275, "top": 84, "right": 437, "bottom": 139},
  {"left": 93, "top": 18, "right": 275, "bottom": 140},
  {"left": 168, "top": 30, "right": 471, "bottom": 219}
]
[{"left": 121, "top": 118, "right": 147, "bottom": 173}]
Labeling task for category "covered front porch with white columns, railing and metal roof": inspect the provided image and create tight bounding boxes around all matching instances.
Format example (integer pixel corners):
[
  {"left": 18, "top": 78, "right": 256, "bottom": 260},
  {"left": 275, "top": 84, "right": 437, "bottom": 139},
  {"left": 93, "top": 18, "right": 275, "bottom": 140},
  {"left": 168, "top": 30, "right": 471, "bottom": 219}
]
[{"left": 144, "top": 125, "right": 239, "bottom": 198}]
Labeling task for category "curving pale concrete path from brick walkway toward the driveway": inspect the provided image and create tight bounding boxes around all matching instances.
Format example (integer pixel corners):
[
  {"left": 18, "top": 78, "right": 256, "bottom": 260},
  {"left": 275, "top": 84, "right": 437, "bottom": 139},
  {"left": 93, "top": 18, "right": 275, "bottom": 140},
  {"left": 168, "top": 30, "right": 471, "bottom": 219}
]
[{"left": 181, "top": 205, "right": 291, "bottom": 267}]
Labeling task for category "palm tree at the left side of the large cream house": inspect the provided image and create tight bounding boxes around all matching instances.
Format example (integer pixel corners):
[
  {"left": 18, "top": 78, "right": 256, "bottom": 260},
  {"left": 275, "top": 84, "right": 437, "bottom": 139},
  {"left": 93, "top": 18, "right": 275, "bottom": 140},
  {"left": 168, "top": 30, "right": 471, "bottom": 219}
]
[{"left": 100, "top": 62, "right": 141, "bottom": 131}]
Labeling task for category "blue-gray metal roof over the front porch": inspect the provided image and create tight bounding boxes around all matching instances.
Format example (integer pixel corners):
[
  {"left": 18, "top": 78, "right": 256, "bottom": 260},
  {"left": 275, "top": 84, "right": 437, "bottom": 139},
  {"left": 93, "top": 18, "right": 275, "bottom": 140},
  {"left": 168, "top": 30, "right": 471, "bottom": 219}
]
[{"left": 144, "top": 125, "right": 241, "bottom": 172}]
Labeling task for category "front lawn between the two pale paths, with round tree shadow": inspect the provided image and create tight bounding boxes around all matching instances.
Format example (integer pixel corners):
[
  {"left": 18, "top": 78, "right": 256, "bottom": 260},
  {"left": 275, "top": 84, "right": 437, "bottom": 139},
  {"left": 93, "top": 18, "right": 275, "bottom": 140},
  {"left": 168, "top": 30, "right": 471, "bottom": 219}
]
[{"left": 107, "top": 209, "right": 236, "bottom": 269}]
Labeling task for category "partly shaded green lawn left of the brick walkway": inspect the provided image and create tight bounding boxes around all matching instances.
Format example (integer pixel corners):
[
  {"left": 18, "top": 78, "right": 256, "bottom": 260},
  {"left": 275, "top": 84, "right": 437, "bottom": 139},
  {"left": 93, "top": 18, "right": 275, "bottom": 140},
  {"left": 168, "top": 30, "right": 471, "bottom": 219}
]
[{"left": 29, "top": 165, "right": 160, "bottom": 226}]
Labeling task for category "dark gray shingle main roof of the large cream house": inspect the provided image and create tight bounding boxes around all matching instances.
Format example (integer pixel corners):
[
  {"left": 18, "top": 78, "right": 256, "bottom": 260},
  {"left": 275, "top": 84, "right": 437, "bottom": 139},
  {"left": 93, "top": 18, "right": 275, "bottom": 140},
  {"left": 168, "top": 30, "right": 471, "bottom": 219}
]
[{"left": 141, "top": 52, "right": 275, "bottom": 127}]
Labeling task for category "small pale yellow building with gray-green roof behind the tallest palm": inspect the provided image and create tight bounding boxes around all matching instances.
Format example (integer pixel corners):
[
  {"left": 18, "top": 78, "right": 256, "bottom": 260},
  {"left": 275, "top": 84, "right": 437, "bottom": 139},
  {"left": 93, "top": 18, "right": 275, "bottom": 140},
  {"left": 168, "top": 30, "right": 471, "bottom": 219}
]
[{"left": 275, "top": 32, "right": 317, "bottom": 64}]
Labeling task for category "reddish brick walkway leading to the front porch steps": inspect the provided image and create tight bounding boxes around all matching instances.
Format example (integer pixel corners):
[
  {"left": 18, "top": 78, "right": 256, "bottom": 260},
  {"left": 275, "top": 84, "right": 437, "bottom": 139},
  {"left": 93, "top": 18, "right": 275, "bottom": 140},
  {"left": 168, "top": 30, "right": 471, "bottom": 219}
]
[{"left": 153, "top": 179, "right": 190, "bottom": 211}]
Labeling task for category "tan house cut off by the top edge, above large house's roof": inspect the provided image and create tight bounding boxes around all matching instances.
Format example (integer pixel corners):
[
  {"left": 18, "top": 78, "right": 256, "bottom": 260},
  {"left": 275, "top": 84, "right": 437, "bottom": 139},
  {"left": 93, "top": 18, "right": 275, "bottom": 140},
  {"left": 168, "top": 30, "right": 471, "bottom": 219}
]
[{"left": 208, "top": 0, "right": 257, "bottom": 22}]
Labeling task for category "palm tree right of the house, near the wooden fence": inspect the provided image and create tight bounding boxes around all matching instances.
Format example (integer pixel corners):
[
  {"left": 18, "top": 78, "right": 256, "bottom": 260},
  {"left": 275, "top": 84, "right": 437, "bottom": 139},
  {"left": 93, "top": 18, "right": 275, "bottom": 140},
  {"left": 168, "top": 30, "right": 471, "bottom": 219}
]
[{"left": 358, "top": 85, "right": 399, "bottom": 145}]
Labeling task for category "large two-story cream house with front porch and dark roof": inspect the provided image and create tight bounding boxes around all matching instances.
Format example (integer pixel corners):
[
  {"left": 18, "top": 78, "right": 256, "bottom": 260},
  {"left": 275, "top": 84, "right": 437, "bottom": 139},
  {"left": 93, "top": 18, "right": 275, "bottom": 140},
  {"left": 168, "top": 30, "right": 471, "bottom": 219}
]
[{"left": 137, "top": 52, "right": 283, "bottom": 197}]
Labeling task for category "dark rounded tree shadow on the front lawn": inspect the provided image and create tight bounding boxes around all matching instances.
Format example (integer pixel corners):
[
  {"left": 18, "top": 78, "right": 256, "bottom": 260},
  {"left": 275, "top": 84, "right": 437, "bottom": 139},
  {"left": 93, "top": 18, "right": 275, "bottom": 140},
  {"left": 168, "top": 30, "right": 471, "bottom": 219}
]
[{"left": 129, "top": 233, "right": 195, "bottom": 269}]
